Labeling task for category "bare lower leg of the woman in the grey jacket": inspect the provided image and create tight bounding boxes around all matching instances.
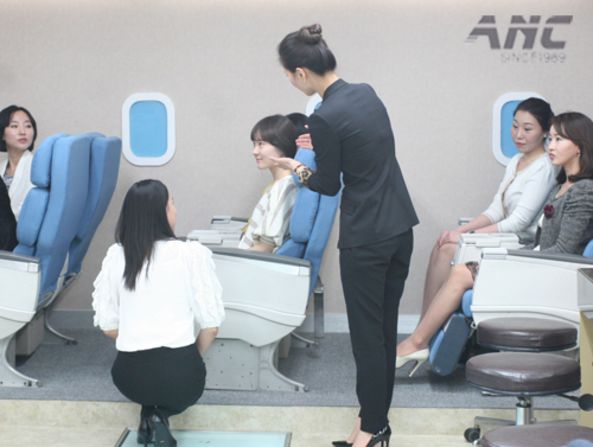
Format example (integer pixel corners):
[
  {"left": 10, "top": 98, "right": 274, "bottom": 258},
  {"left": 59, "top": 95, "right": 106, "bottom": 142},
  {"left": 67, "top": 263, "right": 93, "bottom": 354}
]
[{"left": 397, "top": 264, "right": 474, "bottom": 356}]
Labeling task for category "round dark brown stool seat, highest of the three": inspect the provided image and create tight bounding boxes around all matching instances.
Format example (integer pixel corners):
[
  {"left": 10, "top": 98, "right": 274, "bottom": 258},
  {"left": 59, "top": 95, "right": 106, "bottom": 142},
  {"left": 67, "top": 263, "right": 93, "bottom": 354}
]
[{"left": 477, "top": 318, "right": 577, "bottom": 351}]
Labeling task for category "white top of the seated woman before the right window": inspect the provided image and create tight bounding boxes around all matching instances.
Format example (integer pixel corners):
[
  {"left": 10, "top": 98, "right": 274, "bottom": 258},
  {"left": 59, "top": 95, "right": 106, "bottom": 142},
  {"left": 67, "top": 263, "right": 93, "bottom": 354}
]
[{"left": 482, "top": 154, "right": 556, "bottom": 241}]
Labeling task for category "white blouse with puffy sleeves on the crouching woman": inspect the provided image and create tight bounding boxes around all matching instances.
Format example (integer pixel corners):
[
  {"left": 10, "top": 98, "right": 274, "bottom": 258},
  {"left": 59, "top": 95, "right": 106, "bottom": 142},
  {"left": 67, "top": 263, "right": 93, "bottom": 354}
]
[{"left": 92, "top": 240, "right": 225, "bottom": 351}]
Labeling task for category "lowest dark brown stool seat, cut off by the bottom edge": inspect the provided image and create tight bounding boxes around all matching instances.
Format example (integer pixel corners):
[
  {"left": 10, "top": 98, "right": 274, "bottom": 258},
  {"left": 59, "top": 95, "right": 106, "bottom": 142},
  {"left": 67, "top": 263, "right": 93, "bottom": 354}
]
[{"left": 480, "top": 424, "right": 593, "bottom": 447}]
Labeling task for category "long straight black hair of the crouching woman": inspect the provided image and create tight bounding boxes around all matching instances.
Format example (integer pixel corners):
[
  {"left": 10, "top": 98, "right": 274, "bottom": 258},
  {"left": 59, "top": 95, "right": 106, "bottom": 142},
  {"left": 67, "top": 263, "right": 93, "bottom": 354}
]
[{"left": 115, "top": 179, "right": 175, "bottom": 290}]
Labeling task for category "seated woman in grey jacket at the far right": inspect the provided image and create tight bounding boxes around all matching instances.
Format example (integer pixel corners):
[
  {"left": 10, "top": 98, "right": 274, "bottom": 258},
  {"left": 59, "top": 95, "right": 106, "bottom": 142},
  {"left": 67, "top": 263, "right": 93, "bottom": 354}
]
[{"left": 396, "top": 112, "right": 593, "bottom": 375}]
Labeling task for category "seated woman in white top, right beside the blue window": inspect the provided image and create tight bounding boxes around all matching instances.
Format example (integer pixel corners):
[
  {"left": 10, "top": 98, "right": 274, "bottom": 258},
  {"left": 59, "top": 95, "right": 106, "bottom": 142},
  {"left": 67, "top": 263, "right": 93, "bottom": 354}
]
[{"left": 420, "top": 98, "right": 557, "bottom": 317}]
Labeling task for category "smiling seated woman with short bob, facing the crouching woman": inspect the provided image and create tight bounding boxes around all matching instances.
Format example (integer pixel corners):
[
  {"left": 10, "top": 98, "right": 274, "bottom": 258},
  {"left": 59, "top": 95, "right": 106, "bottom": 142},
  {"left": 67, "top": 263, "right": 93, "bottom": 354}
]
[{"left": 239, "top": 115, "right": 299, "bottom": 253}]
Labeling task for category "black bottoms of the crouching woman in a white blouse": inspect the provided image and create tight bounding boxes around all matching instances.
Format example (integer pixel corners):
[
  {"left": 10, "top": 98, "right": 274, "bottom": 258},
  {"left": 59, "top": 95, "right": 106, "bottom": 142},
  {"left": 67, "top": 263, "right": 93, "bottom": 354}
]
[{"left": 111, "top": 343, "right": 206, "bottom": 418}]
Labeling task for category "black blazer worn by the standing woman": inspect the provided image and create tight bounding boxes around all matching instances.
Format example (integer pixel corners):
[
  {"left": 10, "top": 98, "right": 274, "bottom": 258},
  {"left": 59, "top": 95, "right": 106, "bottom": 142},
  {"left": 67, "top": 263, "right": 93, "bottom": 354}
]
[{"left": 308, "top": 79, "right": 418, "bottom": 248}]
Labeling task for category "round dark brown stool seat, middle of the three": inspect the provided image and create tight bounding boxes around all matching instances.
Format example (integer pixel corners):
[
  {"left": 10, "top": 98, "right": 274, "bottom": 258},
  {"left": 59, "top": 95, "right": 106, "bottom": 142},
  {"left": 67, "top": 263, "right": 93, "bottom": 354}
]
[{"left": 465, "top": 352, "right": 581, "bottom": 396}]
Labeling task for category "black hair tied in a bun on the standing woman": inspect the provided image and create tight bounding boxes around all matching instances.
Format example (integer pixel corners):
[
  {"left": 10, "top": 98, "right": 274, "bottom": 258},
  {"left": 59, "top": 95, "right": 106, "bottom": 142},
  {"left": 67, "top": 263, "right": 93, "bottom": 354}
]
[{"left": 278, "top": 23, "right": 337, "bottom": 75}]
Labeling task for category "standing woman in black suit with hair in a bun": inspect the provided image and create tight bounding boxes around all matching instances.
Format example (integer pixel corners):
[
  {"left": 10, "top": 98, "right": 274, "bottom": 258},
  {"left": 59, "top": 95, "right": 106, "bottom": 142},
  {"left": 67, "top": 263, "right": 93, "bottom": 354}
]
[{"left": 276, "top": 25, "right": 418, "bottom": 447}]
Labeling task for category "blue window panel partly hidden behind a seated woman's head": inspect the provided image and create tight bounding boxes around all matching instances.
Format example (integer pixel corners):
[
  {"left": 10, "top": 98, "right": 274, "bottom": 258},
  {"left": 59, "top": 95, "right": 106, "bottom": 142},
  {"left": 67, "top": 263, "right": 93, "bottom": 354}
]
[{"left": 492, "top": 92, "right": 545, "bottom": 166}]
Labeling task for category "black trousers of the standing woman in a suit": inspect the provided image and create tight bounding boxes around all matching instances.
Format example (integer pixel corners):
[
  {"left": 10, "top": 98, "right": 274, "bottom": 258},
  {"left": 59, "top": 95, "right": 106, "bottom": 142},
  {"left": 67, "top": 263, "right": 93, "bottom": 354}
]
[{"left": 340, "top": 229, "right": 414, "bottom": 433}]
